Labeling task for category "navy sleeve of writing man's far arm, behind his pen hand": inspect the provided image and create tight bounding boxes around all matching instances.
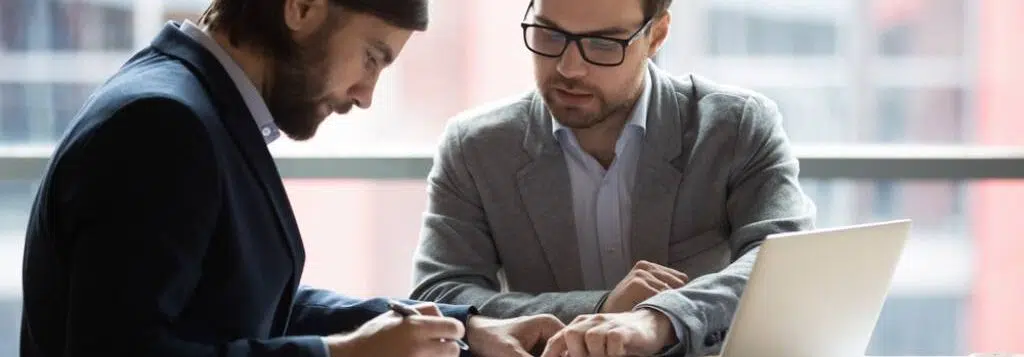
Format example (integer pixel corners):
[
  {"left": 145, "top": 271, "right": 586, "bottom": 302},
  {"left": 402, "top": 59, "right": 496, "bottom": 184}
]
[{"left": 288, "top": 286, "right": 476, "bottom": 336}]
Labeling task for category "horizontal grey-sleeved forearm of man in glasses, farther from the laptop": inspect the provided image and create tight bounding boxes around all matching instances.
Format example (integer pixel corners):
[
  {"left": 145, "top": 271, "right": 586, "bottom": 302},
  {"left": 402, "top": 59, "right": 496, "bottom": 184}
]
[{"left": 413, "top": 281, "right": 608, "bottom": 323}]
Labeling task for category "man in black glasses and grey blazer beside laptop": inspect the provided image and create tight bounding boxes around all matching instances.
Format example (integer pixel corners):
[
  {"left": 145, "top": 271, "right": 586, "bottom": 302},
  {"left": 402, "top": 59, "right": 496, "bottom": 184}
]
[{"left": 413, "top": 0, "right": 815, "bottom": 356}]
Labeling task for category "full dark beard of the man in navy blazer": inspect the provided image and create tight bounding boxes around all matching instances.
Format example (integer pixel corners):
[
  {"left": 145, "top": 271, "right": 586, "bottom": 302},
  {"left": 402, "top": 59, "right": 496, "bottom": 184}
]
[{"left": 265, "top": 21, "right": 352, "bottom": 141}]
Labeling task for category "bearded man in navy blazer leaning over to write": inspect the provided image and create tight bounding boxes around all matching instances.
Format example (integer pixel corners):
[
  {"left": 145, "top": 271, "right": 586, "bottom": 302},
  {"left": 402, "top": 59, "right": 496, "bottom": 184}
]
[{"left": 20, "top": 0, "right": 562, "bottom": 357}]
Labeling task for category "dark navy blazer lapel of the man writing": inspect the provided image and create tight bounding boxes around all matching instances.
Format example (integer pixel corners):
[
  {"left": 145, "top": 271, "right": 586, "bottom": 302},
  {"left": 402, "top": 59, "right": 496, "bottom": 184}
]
[{"left": 153, "top": 23, "right": 304, "bottom": 268}]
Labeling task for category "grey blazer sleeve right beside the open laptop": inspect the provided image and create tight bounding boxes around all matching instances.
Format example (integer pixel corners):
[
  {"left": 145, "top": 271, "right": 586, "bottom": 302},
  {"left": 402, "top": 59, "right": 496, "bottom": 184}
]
[{"left": 638, "top": 95, "right": 815, "bottom": 356}]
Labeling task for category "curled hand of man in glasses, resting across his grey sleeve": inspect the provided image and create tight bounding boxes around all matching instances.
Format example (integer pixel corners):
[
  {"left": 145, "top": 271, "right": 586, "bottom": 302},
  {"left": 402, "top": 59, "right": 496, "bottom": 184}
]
[{"left": 600, "top": 261, "right": 689, "bottom": 313}]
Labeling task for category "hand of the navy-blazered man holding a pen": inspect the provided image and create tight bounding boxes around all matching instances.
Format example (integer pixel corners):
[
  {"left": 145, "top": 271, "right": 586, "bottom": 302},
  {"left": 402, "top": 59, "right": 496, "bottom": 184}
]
[{"left": 325, "top": 304, "right": 466, "bottom": 357}]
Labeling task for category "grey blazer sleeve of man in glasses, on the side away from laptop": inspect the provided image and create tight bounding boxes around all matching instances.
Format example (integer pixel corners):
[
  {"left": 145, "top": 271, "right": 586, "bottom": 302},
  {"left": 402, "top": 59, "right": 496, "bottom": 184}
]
[{"left": 412, "top": 120, "right": 608, "bottom": 323}]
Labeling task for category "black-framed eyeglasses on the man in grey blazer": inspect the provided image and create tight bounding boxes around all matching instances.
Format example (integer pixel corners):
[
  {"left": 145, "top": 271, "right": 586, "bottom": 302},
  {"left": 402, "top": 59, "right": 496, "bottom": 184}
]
[{"left": 520, "top": 1, "right": 653, "bottom": 66}]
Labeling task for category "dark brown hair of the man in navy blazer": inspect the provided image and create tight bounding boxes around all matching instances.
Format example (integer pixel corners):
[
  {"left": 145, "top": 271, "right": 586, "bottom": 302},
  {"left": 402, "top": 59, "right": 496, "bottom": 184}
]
[{"left": 200, "top": 0, "right": 428, "bottom": 53}]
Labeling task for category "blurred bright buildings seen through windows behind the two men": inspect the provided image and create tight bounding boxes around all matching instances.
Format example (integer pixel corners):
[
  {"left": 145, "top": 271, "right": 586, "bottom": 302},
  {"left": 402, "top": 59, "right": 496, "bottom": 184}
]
[{"left": 0, "top": 0, "right": 1024, "bottom": 357}]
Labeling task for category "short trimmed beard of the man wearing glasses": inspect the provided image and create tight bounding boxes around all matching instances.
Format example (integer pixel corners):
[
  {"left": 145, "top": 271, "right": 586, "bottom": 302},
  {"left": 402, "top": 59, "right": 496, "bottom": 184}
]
[{"left": 541, "top": 75, "right": 632, "bottom": 130}]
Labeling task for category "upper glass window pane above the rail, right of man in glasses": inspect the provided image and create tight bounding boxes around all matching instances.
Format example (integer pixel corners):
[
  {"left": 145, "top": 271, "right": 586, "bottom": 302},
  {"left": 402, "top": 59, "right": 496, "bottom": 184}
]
[{"left": 658, "top": 0, "right": 1003, "bottom": 145}]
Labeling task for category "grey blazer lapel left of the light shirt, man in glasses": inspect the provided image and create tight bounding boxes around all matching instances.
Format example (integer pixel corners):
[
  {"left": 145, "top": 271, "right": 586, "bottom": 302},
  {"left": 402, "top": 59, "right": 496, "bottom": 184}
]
[{"left": 517, "top": 95, "right": 584, "bottom": 292}]
